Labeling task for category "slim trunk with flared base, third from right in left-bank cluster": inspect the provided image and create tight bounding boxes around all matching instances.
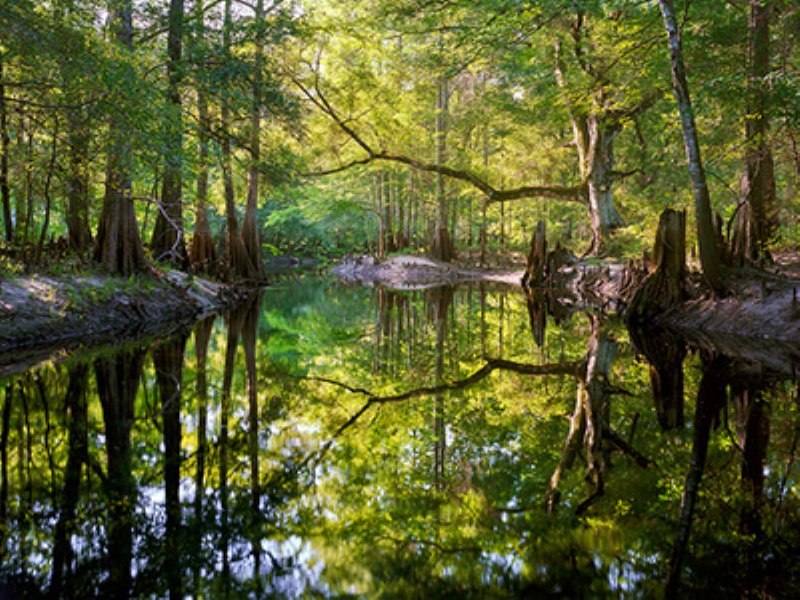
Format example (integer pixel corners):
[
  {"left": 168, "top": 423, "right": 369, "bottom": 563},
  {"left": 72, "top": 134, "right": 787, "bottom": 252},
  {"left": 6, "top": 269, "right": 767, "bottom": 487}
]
[{"left": 189, "top": 0, "right": 217, "bottom": 272}]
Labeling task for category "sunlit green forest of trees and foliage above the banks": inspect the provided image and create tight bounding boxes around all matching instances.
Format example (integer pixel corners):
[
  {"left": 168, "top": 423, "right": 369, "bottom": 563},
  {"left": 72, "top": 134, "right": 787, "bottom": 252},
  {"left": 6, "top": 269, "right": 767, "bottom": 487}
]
[{"left": 0, "top": 0, "right": 800, "bottom": 272}]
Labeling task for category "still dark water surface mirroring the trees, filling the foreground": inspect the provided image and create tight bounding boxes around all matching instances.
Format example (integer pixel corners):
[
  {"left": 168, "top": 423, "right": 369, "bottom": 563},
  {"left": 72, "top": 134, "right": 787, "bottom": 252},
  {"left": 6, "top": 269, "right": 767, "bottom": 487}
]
[{"left": 0, "top": 277, "right": 800, "bottom": 598}]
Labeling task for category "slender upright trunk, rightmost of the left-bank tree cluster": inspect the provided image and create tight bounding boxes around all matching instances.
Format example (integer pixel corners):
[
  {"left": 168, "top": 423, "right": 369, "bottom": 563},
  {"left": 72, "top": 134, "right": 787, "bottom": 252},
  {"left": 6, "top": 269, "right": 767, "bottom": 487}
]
[{"left": 242, "top": 0, "right": 265, "bottom": 279}]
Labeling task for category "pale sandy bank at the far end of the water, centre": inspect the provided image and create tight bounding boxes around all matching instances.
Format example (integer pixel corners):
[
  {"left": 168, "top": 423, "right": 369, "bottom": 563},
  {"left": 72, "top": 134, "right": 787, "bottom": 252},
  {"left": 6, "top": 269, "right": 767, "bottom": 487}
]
[{"left": 331, "top": 255, "right": 524, "bottom": 290}]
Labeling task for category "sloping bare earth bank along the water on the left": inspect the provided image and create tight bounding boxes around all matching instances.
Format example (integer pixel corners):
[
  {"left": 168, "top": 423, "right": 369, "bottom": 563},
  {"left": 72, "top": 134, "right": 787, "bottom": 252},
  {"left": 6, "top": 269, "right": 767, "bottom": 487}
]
[{"left": 0, "top": 271, "right": 242, "bottom": 375}]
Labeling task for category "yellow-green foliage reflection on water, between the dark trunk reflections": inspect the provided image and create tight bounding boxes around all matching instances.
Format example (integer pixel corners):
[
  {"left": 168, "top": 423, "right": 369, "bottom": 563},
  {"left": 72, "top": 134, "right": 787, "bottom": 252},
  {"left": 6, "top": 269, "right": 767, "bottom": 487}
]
[{"left": 0, "top": 277, "right": 800, "bottom": 597}]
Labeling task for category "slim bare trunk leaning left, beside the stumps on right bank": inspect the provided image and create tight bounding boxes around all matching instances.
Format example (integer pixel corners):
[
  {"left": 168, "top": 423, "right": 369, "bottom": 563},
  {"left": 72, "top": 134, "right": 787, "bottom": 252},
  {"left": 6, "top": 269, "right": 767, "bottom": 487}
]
[{"left": 658, "top": 0, "right": 724, "bottom": 294}]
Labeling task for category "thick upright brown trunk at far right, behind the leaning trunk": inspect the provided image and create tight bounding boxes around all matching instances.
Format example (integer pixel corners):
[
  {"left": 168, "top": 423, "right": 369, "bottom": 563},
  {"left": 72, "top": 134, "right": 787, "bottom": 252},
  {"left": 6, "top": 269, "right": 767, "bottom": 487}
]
[{"left": 733, "top": 0, "right": 778, "bottom": 260}]
